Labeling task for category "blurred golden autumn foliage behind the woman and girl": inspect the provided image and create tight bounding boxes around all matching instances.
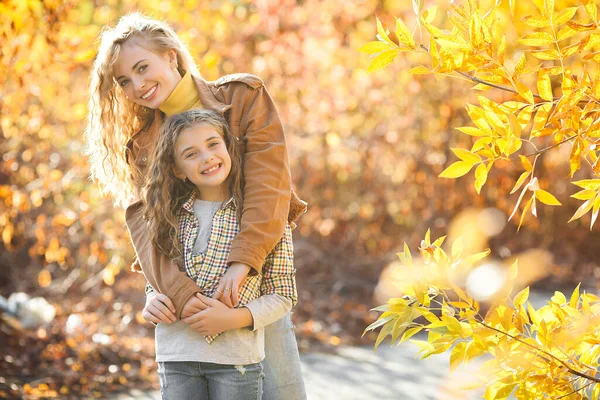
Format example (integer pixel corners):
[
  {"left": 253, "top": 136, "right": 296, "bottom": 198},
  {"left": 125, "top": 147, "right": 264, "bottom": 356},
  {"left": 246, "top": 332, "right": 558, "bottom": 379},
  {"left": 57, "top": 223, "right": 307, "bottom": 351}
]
[{"left": 0, "top": 0, "right": 600, "bottom": 397}]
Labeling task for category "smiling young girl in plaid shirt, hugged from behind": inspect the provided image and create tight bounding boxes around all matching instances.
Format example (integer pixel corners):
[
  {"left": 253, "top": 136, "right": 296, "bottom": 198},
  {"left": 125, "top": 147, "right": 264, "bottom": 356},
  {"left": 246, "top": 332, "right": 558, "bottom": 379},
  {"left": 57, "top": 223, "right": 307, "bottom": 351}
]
[{"left": 143, "top": 109, "right": 296, "bottom": 399}]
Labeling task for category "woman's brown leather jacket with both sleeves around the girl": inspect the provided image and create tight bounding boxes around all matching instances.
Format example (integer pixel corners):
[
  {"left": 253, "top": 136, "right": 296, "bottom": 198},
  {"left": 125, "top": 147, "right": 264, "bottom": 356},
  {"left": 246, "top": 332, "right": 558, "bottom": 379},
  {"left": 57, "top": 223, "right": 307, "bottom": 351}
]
[{"left": 125, "top": 74, "right": 306, "bottom": 316}]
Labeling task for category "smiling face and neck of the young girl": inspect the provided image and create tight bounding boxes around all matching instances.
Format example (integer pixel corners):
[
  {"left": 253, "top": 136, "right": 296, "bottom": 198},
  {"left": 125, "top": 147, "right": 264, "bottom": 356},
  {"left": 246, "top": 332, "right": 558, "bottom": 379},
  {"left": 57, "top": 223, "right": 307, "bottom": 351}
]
[{"left": 173, "top": 125, "right": 231, "bottom": 201}]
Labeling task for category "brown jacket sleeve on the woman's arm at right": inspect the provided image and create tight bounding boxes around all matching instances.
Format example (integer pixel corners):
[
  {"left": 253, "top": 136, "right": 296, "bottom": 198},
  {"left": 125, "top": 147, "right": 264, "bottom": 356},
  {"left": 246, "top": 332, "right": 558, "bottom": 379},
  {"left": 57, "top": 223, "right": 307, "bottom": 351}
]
[{"left": 228, "top": 85, "right": 291, "bottom": 272}]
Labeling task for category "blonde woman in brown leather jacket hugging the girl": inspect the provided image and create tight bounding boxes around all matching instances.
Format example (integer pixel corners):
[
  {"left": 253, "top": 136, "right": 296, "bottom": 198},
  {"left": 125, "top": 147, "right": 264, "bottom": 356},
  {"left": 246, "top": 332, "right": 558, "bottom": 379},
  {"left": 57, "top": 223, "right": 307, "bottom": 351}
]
[{"left": 86, "top": 14, "right": 306, "bottom": 400}]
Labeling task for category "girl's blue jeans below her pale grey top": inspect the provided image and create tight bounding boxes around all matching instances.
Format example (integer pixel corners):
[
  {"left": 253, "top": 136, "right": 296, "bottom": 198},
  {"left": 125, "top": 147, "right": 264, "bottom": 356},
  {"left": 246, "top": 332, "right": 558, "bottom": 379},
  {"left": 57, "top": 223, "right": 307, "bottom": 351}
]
[{"left": 158, "top": 361, "right": 265, "bottom": 400}]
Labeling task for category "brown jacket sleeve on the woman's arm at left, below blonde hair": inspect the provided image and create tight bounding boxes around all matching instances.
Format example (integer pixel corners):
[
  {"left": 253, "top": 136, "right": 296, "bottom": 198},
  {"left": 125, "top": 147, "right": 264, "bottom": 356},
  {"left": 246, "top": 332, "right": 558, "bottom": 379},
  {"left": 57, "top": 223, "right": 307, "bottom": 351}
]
[{"left": 125, "top": 202, "right": 200, "bottom": 318}]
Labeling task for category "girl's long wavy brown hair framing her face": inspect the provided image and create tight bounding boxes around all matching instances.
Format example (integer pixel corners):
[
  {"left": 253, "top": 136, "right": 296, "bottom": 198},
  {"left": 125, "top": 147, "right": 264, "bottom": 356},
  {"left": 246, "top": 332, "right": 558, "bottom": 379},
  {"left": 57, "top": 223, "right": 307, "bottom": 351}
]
[{"left": 142, "top": 109, "right": 244, "bottom": 265}]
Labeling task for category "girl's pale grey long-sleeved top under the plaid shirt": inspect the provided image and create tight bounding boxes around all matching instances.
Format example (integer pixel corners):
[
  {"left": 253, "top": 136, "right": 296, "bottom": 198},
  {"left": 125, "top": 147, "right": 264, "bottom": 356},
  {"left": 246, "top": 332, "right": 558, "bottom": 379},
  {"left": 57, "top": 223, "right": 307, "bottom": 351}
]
[{"left": 147, "top": 200, "right": 292, "bottom": 365}]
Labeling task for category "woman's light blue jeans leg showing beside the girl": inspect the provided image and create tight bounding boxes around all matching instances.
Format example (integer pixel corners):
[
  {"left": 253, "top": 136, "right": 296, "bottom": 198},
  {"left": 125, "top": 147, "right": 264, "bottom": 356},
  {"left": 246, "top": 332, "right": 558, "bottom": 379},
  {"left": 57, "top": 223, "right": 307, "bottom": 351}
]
[{"left": 262, "top": 313, "right": 306, "bottom": 400}]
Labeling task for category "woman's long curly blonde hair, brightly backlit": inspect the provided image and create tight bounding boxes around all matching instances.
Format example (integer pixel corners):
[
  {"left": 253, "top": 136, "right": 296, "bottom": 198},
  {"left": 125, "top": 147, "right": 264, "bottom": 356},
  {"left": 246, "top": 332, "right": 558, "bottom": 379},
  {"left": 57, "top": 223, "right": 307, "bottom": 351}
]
[{"left": 85, "top": 13, "right": 200, "bottom": 206}]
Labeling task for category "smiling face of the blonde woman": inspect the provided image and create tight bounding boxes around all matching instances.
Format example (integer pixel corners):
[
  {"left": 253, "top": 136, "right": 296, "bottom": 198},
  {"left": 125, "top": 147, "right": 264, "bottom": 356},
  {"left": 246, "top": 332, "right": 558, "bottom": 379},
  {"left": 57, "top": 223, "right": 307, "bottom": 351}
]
[{"left": 113, "top": 38, "right": 181, "bottom": 109}]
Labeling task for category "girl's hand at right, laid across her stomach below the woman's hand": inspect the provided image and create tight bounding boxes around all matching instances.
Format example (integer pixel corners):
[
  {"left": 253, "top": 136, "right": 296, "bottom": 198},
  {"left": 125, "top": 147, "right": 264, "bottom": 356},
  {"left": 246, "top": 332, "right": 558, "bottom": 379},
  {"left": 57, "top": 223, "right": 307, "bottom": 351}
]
[{"left": 182, "top": 293, "right": 253, "bottom": 336}]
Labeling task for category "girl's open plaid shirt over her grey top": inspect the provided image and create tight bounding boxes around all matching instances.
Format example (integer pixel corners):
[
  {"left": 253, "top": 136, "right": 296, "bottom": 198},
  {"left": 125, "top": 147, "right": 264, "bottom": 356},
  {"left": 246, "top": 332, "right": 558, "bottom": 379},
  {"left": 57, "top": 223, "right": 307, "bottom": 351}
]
[{"left": 146, "top": 195, "right": 297, "bottom": 343}]
